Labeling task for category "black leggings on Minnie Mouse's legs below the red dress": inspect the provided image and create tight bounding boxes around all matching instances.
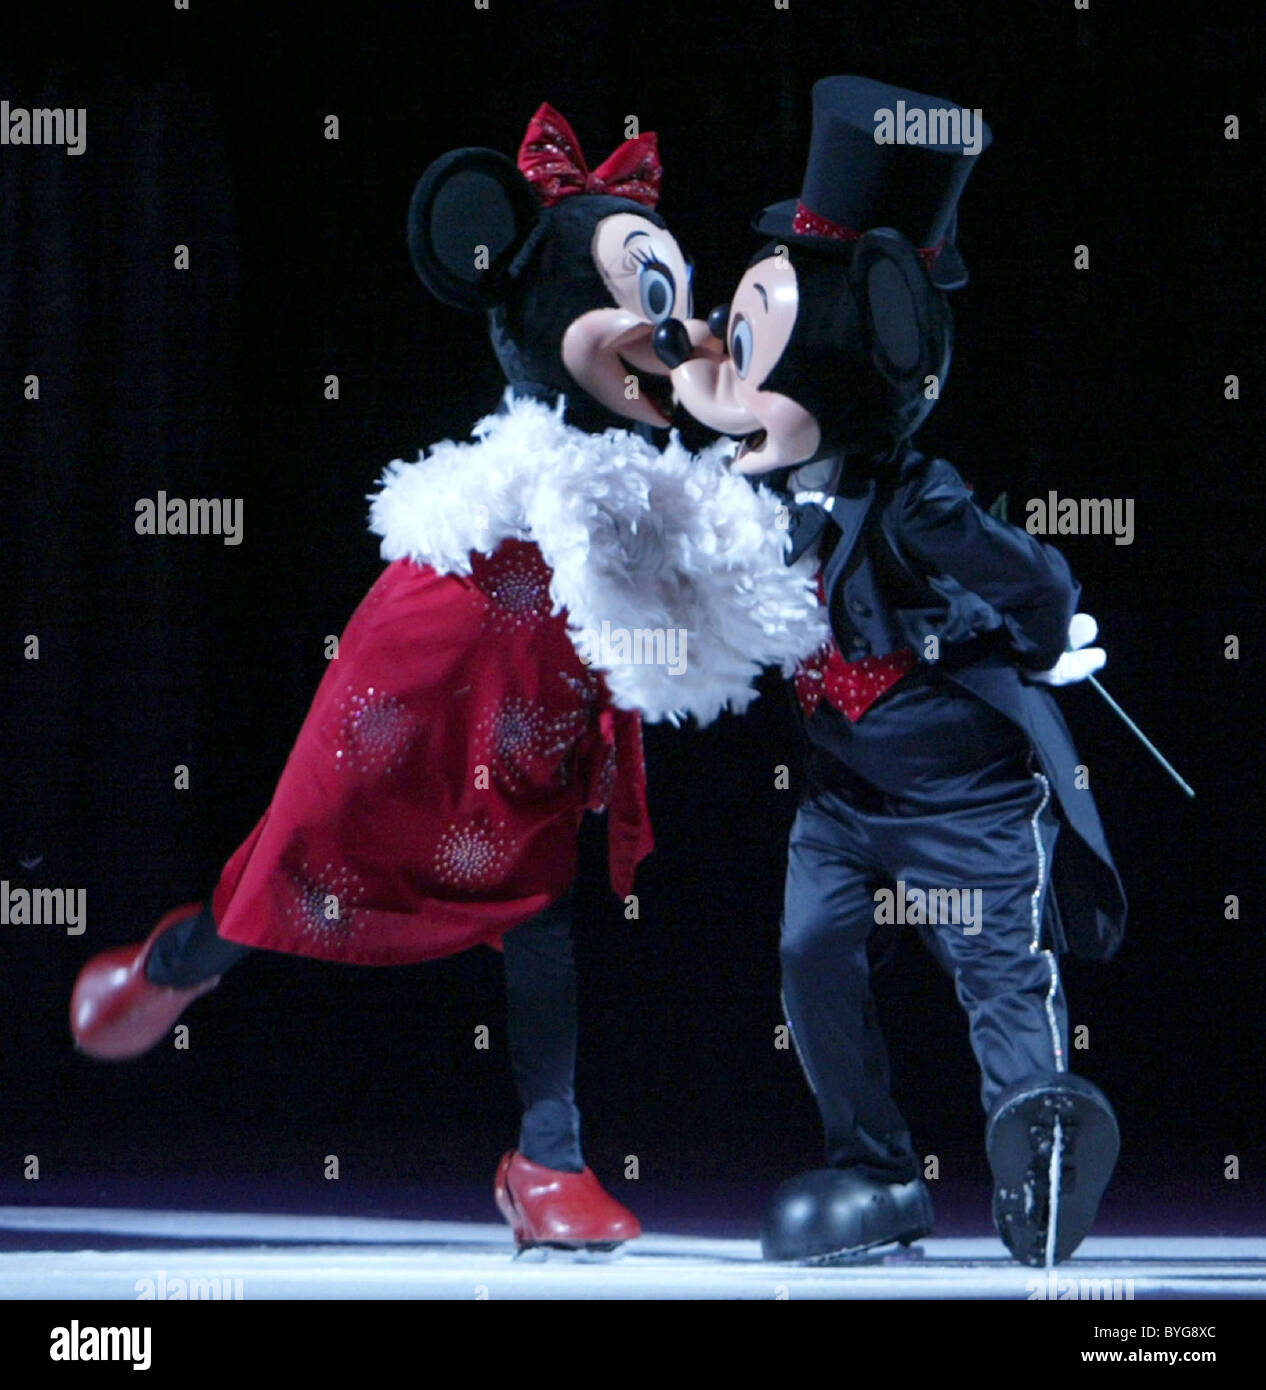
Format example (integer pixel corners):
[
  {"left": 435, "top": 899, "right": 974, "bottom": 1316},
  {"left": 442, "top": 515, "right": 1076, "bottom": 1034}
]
[{"left": 146, "top": 898, "right": 585, "bottom": 1173}]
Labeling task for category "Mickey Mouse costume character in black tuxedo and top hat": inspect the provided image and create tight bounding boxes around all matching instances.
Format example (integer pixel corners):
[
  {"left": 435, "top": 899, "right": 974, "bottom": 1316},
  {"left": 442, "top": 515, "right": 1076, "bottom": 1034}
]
[{"left": 656, "top": 78, "right": 1126, "bottom": 1265}]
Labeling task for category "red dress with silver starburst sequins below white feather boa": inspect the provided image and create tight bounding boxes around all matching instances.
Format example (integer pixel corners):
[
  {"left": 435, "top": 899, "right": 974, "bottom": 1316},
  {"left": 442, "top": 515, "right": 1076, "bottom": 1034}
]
[{"left": 211, "top": 539, "right": 652, "bottom": 965}]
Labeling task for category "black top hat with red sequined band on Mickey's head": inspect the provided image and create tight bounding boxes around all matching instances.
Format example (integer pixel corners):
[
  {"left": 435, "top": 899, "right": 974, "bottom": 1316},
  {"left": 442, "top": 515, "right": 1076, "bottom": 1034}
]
[{"left": 753, "top": 78, "right": 994, "bottom": 289}]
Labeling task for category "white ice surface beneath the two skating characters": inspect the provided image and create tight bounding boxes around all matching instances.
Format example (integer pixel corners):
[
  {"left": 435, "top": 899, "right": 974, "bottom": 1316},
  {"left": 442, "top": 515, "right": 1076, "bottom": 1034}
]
[{"left": 0, "top": 1207, "right": 1266, "bottom": 1300}]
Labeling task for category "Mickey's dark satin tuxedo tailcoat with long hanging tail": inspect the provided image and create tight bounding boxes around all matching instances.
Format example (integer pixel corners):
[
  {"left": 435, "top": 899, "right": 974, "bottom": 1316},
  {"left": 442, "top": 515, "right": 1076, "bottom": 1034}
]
[{"left": 791, "top": 448, "right": 1126, "bottom": 959}]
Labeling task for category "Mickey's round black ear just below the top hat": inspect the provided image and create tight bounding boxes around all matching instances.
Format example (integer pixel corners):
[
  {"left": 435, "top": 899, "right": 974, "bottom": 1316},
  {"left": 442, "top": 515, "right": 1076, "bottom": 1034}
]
[{"left": 852, "top": 227, "right": 944, "bottom": 389}]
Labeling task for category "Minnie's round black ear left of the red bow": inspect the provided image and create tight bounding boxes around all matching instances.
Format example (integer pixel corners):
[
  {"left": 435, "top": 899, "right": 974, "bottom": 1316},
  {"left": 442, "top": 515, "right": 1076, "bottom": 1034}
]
[{"left": 409, "top": 149, "right": 541, "bottom": 310}]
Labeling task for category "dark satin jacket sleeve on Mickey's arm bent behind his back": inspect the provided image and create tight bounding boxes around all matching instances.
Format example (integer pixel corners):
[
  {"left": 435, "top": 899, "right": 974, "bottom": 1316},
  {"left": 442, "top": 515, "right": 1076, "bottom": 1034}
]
[{"left": 898, "top": 459, "right": 1081, "bottom": 671}]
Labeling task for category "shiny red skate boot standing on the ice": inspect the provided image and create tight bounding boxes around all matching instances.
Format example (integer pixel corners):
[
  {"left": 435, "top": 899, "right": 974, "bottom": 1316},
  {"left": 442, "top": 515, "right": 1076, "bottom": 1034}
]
[{"left": 493, "top": 1152, "right": 642, "bottom": 1250}]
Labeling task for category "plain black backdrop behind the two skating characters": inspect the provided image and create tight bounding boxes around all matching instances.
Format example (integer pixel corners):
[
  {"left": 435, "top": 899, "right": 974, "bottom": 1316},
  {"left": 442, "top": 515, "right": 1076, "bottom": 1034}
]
[{"left": 0, "top": 0, "right": 1266, "bottom": 1230}]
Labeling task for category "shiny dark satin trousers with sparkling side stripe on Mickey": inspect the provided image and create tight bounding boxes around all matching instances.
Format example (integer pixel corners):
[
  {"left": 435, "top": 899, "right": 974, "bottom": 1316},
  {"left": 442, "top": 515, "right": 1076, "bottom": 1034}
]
[{"left": 781, "top": 760, "right": 1067, "bottom": 1182}]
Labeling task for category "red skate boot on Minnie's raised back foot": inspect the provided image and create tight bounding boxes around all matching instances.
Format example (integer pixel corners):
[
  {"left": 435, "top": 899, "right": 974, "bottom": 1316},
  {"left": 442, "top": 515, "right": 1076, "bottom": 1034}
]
[{"left": 71, "top": 902, "right": 220, "bottom": 1062}]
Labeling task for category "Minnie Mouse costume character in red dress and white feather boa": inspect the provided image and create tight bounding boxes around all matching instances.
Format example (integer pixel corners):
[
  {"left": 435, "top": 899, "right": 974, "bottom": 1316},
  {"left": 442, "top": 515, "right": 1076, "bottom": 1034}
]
[{"left": 71, "top": 106, "right": 821, "bottom": 1248}]
